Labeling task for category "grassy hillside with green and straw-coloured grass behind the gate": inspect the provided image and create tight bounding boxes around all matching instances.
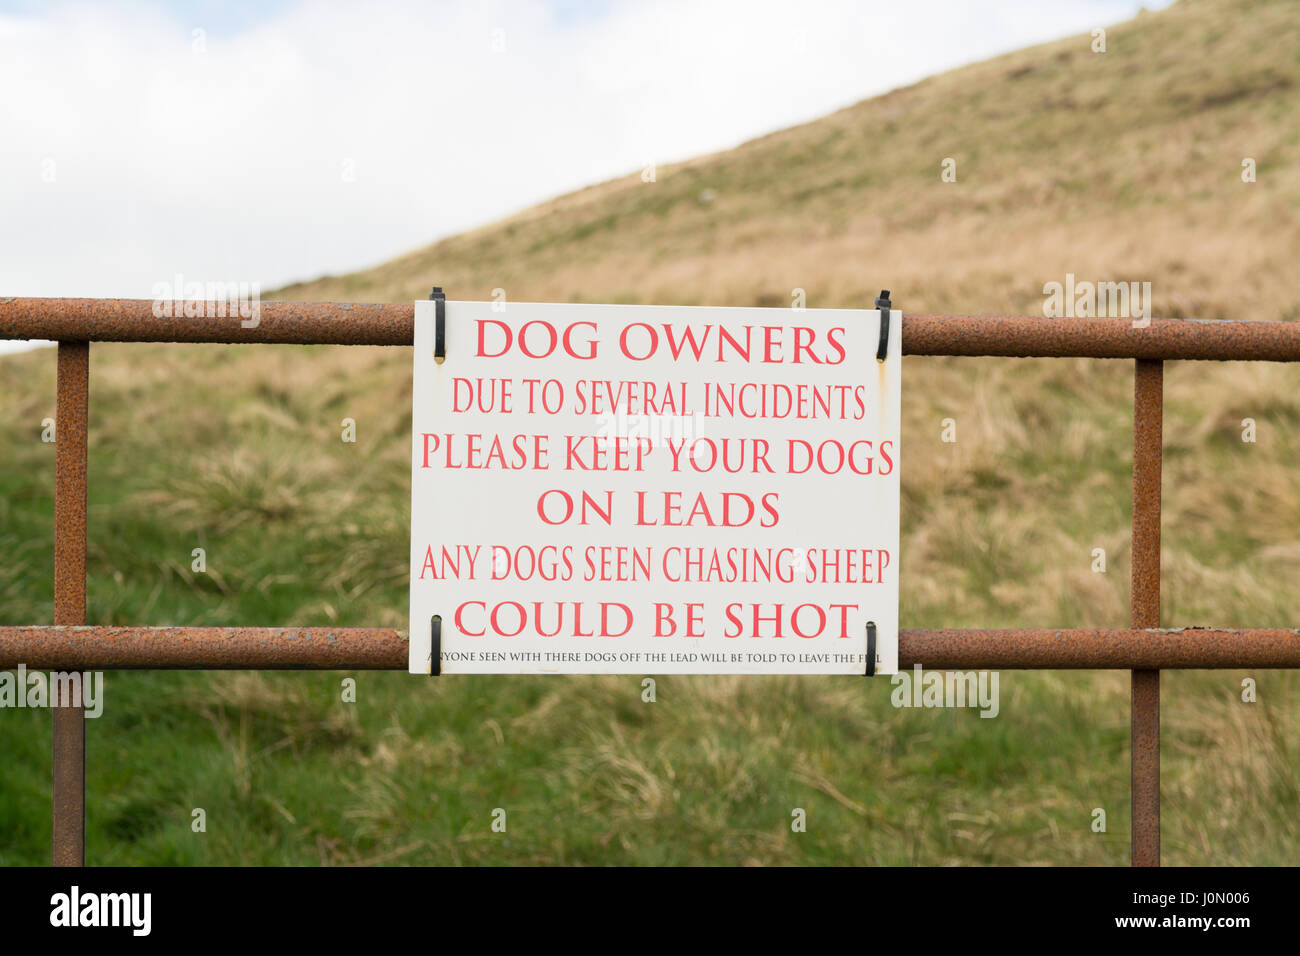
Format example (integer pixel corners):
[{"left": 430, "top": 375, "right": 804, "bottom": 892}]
[{"left": 0, "top": 0, "right": 1300, "bottom": 864}]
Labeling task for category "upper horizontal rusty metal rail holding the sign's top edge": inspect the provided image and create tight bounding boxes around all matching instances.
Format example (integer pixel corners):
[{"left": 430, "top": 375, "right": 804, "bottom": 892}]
[{"left": 0, "top": 298, "right": 1300, "bottom": 362}]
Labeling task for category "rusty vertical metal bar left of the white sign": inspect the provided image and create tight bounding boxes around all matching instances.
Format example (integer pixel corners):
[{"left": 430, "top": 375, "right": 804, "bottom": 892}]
[{"left": 51, "top": 342, "right": 90, "bottom": 866}]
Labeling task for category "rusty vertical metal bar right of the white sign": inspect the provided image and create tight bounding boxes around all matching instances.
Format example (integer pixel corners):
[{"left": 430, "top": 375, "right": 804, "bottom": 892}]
[{"left": 1130, "top": 359, "right": 1165, "bottom": 866}]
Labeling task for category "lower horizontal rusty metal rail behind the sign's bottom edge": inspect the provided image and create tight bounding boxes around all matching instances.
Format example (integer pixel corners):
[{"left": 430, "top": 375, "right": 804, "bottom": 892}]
[{"left": 0, "top": 627, "right": 1300, "bottom": 671}]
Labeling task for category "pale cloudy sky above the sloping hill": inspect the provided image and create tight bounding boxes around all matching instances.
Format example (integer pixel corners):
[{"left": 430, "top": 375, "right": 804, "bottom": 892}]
[{"left": 0, "top": 0, "right": 1167, "bottom": 347}]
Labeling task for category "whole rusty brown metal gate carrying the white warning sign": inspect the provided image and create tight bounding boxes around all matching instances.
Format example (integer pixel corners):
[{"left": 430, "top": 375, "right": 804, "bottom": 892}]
[{"left": 0, "top": 298, "right": 1300, "bottom": 866}]
